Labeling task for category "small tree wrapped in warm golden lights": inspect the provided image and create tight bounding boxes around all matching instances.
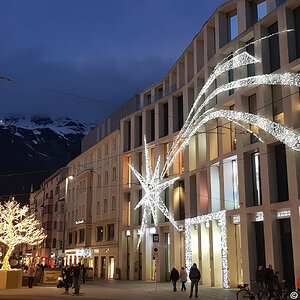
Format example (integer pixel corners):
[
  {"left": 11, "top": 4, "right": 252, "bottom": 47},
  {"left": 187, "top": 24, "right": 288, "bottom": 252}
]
[{"left": 0, "top": 198, "right": 47, "bottom": 270}]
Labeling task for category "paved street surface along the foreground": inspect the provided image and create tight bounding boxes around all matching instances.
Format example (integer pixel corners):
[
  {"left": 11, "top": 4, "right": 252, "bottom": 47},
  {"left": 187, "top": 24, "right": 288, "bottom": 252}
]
[{"left": 0, "top": 280, "right": 236, "bottom": 300}]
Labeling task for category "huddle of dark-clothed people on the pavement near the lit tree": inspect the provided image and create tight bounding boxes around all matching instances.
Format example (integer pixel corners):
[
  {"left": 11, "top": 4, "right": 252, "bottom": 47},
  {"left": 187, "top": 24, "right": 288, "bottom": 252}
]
[{"left": 62, "top": 263, "right": 86, "bottom": 295}]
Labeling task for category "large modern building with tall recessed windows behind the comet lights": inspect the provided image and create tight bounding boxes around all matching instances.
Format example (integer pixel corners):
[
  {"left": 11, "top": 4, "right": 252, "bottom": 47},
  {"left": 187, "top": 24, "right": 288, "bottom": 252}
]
[{"left": 119, "top": 0, "right": 300, "bottom": 287}]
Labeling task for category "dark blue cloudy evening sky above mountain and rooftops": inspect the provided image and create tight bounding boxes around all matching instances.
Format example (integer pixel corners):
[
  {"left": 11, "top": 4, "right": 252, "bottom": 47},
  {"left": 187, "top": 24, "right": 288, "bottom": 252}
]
[{"left": 0, "top": 0, "right": 224, "bottom": 121}]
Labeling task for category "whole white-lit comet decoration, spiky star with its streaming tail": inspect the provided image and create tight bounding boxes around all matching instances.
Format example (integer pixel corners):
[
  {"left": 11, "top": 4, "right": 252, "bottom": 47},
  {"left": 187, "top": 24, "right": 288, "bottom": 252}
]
[{"left": 130, "top": 29, "right": 300, "bottom": 253}]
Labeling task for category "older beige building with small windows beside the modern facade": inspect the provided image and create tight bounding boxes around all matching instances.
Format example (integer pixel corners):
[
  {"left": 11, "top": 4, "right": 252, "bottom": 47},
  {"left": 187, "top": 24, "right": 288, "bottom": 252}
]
[{"left": 61, "top": 130, "right": 120, "bottom": 278}]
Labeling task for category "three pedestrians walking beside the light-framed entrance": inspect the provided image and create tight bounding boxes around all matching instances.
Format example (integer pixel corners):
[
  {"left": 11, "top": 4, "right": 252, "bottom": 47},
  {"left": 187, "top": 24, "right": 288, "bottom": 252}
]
[{"left": 170, "top": 263, "right": 201, "bottom": 298}]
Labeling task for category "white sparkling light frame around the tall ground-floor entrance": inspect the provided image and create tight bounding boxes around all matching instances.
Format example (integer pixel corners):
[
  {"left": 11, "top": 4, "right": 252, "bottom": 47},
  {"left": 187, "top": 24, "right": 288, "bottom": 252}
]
[{"left": 184, "top": 210, "right": 229, "bottom": 288}]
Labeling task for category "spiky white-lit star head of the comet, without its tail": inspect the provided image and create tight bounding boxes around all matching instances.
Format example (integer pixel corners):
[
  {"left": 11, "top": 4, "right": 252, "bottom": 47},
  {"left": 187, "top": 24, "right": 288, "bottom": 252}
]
[{"left": 128, "top": 138, "right": 180, "bottom": 248}]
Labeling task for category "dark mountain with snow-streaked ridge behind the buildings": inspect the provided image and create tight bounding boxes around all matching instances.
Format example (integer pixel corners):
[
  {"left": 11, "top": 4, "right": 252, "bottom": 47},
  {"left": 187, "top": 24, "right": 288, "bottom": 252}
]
[{"left": 0, "top": 117, "right": 96, "bottom": 203}]
